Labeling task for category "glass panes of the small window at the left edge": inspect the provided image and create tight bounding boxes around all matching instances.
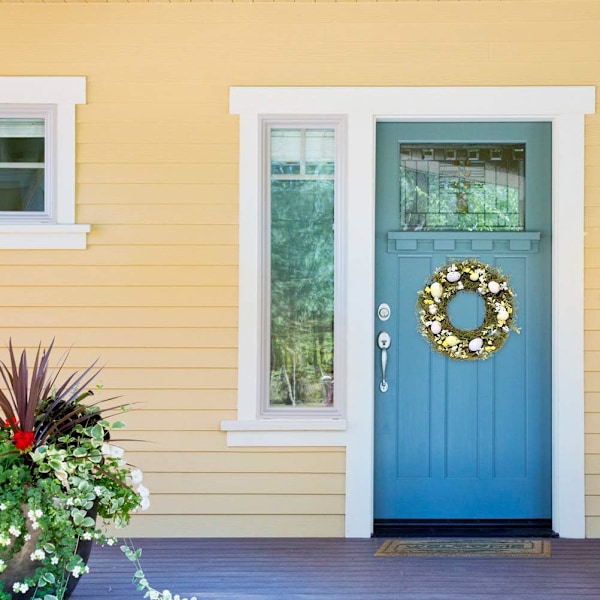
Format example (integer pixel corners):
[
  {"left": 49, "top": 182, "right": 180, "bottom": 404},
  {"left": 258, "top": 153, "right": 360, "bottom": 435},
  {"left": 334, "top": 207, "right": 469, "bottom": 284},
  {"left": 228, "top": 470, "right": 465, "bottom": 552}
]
[{"left": 0, "top": 118, "right": 47, "bottom": 217}]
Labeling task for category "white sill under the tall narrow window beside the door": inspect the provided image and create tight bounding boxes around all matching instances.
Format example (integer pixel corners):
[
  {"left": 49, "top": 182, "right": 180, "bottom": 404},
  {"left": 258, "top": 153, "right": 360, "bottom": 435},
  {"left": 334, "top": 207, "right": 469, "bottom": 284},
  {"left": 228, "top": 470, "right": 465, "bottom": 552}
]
[{"left": 221, "top": 419, "right": 347, "bottom": 446}]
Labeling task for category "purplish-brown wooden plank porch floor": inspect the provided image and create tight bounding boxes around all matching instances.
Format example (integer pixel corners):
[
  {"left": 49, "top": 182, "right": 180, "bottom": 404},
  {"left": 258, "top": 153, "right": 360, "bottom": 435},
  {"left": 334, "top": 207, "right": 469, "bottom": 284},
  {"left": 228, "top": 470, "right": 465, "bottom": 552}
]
[{"left": 71, "top": 538, "right": 600, "bottom": 600}]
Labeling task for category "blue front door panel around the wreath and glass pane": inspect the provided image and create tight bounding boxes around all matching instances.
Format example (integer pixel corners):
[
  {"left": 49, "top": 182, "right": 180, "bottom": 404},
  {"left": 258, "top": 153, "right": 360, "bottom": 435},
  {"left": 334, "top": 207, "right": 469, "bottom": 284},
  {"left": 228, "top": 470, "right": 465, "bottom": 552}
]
[{"left": 375, "top": 123, "right": 551, "bottom": 519}]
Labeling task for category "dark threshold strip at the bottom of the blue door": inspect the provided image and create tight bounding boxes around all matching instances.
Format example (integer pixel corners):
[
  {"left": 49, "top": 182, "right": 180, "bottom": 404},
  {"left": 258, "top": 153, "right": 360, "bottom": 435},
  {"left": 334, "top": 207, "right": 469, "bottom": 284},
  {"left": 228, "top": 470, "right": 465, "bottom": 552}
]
[{"left": 373, "top": 519, "right": 558, "bottom": 538}]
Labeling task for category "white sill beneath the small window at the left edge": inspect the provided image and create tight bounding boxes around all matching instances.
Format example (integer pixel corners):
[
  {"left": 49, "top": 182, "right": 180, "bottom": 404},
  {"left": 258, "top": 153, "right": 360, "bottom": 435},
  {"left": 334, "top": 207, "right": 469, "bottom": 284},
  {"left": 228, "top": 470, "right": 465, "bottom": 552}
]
[{"left": 0, "top": 223, "right": 91, "bottom": 250}]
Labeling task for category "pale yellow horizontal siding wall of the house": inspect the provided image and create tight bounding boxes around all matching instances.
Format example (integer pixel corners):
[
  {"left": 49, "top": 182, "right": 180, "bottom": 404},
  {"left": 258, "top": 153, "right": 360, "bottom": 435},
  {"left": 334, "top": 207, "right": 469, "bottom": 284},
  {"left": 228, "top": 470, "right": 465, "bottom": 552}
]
[{"left": 0, "top": 0, "right": 600, "bottom": 536}]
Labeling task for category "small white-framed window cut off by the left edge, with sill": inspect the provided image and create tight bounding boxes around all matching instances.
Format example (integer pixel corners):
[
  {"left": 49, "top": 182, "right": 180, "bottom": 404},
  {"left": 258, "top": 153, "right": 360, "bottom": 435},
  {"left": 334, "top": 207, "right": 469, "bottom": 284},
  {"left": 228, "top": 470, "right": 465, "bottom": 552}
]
[{"left": 0, "top": 77, "right": 90, "bottom": 249}]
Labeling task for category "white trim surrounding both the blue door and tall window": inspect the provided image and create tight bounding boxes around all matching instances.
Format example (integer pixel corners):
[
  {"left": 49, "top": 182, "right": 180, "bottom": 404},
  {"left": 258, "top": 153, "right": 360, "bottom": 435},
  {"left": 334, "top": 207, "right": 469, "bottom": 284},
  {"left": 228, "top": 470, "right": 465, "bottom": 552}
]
[{"left": 222, "top": 86, "right": 595, "bottom": 538}]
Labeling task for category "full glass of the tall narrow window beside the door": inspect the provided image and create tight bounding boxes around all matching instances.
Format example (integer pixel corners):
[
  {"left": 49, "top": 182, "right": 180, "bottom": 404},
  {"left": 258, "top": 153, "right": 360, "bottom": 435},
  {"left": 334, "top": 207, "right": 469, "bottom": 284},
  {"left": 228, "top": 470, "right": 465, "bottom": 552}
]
[{"left": 268, "top": 127, "right": 336, "bottom": 409}]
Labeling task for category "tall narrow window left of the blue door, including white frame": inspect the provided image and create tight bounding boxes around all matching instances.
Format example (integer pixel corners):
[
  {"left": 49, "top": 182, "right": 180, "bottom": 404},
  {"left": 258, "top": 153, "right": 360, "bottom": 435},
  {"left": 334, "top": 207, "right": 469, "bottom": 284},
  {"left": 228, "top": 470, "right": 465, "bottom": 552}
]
[{"left": 221, "top": 115, "right": 346, "bottom": 432}]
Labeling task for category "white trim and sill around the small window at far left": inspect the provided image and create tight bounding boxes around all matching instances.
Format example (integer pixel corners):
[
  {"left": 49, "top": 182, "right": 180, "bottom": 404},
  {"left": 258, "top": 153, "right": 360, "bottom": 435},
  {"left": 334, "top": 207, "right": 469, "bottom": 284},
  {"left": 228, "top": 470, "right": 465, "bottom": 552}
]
[{"left": 0, "top": 77, "right": 91, "bottom": 250}]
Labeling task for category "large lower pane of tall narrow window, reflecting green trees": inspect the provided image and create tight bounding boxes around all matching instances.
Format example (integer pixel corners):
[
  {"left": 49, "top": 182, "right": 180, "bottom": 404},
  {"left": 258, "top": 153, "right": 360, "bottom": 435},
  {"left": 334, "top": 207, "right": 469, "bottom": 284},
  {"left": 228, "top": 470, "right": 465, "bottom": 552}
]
[{"left": 270, "top": 179, "right": 334, "bottom": 405}]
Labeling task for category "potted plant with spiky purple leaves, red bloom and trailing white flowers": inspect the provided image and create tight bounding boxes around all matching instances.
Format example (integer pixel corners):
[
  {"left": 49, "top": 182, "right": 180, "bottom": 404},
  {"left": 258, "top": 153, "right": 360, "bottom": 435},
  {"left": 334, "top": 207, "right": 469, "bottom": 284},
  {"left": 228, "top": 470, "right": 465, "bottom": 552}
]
[{"left": 0, "top": 342, "right": 193, "bottom": 600}]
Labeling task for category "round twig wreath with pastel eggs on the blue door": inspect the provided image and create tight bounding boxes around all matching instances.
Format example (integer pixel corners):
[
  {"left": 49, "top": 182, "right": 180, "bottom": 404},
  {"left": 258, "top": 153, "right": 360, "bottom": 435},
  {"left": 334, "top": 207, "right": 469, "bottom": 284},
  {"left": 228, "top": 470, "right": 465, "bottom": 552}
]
[{"left": 417, "top": 258, "right": 519, "bottom": 360}]
